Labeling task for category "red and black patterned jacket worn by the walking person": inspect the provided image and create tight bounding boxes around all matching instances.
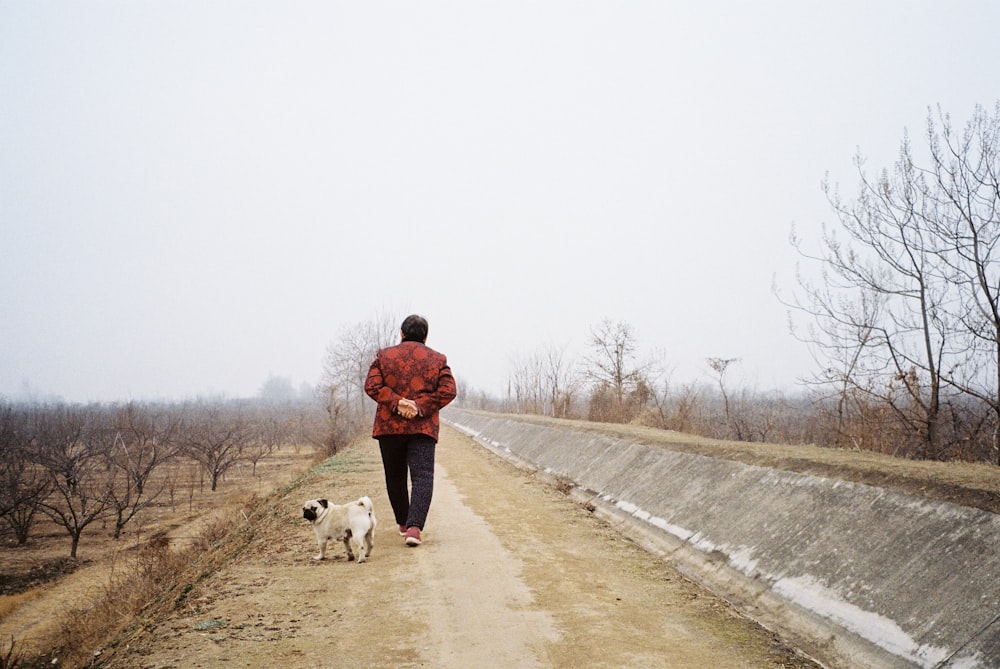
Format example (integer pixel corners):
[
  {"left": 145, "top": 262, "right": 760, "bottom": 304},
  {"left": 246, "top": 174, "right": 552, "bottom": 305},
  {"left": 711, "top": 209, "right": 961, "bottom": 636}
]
[{"left": 365, "top": 341, "right": 455, "bottom": 441}]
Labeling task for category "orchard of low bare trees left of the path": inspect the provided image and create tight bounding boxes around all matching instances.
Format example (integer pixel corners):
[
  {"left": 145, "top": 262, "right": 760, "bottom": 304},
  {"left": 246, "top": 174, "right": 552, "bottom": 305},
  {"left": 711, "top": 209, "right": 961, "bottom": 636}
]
[{"left": 0, "top": 401, "right": 329, "bottom": 558}]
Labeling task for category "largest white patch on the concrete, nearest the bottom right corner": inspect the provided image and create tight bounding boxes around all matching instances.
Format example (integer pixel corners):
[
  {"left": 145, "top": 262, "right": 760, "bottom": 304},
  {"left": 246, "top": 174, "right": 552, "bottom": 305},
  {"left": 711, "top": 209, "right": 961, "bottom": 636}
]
[{"left": 772, "top": 576, "right": 957, "bottom": 667}]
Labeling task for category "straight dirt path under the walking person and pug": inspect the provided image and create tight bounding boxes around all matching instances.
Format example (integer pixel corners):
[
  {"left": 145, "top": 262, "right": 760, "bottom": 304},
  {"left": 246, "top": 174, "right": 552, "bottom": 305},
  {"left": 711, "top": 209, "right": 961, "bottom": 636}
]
[{"left": 108, "top": 428, "right": 815, "bottom": 669}]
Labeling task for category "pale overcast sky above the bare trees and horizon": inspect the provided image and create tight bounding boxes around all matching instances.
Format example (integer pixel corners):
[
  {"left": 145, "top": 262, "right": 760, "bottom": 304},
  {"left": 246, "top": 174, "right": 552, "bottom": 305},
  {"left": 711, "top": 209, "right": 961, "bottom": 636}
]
[{"left": 0, "top": 0, "right": 1000, "bottom": 402}]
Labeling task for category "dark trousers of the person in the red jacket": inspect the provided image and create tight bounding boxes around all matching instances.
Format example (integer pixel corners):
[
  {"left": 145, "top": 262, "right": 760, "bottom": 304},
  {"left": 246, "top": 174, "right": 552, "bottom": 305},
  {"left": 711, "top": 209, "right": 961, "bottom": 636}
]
[{"left": 378, "top": 434, "right": 437, "bottom": 530}]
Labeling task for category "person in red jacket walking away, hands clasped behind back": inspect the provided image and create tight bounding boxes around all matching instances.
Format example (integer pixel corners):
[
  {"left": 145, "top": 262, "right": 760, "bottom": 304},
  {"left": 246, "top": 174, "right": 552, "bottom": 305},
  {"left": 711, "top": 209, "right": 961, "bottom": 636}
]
[{"left": 365, "top": 315, "right": 455, "bottom": 546}]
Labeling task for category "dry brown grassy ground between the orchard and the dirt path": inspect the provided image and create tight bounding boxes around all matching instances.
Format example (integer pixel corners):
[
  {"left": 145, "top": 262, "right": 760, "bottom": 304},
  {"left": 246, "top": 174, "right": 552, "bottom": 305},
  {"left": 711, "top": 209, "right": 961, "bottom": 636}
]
[{"left": 0, "top": 440, "right": 317, "bottom": 669}]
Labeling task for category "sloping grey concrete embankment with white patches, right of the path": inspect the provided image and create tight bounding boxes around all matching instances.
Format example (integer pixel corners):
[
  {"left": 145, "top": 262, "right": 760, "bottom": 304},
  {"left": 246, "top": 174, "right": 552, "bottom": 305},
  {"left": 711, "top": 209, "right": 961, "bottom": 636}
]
[{"left": 443, "top": 408, "right": 1000, "bottom": 668}]
